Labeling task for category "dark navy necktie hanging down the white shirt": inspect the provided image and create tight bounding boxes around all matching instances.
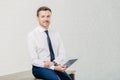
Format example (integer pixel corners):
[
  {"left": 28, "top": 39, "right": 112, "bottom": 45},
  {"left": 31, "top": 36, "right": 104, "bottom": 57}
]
[{"left": 45, "top": 30, "right": 55, "bottom": 61}]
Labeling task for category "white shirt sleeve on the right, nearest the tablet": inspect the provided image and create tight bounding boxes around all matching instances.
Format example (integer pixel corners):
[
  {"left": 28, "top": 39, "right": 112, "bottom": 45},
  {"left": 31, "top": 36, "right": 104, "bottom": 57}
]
[{"left": 54, "top": 34, "right": 66, "bottom": 64}]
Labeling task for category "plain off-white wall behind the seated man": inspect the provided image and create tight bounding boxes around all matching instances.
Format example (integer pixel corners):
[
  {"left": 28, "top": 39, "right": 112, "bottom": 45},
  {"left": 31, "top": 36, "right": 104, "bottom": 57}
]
[{"left": 0, "top": 0, "right": 120, "bottom": 80}]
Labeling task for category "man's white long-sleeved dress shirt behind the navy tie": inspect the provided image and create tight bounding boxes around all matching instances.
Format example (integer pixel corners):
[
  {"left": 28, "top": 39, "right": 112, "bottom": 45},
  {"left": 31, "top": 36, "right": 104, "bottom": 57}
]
[{"left": 27, "top": 26, "right": 65, "bottom": 69}]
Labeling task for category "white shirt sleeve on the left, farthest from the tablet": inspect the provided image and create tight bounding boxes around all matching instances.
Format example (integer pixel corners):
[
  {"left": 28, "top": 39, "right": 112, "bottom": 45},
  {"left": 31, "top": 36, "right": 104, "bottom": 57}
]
[{"left": 27, "top": 35, "right": 44, "bottom": 67}]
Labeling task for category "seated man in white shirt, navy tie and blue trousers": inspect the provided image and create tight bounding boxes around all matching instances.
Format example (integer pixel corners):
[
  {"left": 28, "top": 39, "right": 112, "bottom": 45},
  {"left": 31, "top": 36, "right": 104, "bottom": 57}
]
[{"left": 28, "top": 6, "right": 71, "bottom": 80}]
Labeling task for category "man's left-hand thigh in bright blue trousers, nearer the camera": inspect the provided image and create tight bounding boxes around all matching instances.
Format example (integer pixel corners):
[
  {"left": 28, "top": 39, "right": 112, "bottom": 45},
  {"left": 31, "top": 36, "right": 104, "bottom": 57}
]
[{"left": 32, "top": 67, "right": 59, "bottom": 80}]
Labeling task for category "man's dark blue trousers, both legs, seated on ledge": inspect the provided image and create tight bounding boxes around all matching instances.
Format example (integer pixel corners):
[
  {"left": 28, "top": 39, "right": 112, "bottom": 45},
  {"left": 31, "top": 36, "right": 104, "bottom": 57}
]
[{"left": 32, "top": 66, "right": 71, "bottom": 80}]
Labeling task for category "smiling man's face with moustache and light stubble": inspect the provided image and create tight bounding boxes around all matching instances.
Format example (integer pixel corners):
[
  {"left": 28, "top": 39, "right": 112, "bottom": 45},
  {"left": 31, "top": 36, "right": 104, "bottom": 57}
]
[{"left": 37, "top": 10, "right": 51, "bottom": 29}]
